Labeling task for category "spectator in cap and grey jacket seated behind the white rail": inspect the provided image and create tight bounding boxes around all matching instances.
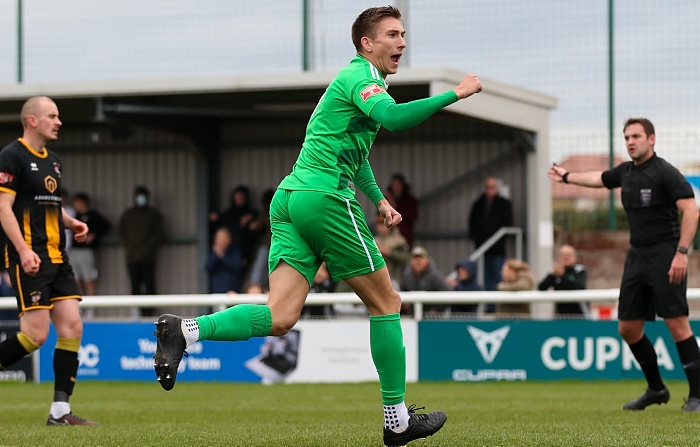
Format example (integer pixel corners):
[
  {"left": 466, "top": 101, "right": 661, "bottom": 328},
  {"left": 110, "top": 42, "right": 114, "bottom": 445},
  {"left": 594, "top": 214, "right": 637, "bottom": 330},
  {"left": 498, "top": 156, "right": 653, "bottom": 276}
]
[{"left": 401, "top": 245, "right": 452, "bottom": 315}]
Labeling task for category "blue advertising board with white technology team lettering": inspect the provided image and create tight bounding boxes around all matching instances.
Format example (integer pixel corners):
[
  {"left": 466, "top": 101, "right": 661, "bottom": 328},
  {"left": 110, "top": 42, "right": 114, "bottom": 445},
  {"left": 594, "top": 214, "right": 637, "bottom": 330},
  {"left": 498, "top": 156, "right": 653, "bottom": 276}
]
[{"left": 39, "top": 322, "right": 265, "bottom": 382}]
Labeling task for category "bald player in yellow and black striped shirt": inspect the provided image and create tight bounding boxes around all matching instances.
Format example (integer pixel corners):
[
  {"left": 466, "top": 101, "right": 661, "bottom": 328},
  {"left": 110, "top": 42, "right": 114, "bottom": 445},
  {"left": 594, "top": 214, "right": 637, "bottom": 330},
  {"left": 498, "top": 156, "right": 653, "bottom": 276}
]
[{"left": 0, "top": 96, "right": 97, "bottom": 425}]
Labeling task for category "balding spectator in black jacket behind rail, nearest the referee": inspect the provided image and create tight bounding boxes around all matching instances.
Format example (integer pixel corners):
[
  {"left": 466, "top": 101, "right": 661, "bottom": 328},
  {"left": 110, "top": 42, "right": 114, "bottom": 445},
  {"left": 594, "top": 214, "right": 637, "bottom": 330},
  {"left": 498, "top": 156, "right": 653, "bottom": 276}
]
[{"left": 537, "top": 245, "right": 588, "bottom": 316}]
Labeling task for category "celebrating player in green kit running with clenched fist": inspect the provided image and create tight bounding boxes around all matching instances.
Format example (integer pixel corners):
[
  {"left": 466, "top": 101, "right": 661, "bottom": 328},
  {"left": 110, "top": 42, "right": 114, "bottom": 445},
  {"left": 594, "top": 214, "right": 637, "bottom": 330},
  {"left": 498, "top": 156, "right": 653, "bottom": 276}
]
[{"left": 155, "top": 6, "right": 481, "bottom": 446}]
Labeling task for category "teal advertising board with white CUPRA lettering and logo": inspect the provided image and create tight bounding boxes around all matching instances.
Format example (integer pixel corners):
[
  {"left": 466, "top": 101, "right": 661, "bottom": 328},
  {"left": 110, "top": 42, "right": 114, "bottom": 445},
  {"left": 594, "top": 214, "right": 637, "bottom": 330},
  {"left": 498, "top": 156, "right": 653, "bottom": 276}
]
[{"left": 418, "top": 320, "right": 700, "bottom": 382}]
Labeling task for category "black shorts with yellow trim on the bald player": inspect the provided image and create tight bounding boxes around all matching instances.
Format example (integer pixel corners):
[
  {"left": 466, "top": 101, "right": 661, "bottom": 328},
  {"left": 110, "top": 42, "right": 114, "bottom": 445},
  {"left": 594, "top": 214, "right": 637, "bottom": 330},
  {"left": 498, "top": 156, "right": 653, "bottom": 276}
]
[{"left": 8, "top": 260, "right": 82, "bottom": 315}]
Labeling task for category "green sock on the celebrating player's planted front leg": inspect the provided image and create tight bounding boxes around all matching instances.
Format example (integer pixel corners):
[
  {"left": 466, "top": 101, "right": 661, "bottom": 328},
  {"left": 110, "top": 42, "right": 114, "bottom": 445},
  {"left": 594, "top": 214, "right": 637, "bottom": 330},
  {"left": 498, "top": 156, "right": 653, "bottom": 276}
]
[{"left": 369, "top": 314, "right": 406, "bottom": 405}]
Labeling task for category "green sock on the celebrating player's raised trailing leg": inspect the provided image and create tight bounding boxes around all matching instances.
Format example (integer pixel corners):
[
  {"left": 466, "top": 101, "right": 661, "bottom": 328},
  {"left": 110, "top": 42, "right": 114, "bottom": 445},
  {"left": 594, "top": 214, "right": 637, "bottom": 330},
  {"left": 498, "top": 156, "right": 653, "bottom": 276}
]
[{"left": 194, "top": 304, "right": 272, "bottom": 341}]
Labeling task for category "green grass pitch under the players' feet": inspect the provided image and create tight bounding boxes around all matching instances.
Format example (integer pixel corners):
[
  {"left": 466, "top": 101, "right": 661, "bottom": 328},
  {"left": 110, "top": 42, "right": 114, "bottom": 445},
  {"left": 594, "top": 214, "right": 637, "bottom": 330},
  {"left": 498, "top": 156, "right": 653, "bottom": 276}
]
[{"left": 0, "top": 381, "right": 700, "bottom": 447}]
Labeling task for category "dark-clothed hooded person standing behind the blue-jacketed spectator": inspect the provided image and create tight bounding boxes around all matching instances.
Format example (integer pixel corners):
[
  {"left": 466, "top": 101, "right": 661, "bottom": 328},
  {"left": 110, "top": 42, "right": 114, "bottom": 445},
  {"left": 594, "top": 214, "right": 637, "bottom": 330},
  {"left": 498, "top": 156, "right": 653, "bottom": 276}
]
[{"left": 216, "top": 185, "right": 258, "bottom": 272}]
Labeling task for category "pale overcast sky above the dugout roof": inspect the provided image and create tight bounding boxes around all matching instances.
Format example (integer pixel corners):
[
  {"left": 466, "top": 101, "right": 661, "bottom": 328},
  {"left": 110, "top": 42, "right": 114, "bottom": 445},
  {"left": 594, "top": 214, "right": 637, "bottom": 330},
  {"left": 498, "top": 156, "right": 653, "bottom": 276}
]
[{"left": 0, "top": 0, "right": 700, "bottom": 164}]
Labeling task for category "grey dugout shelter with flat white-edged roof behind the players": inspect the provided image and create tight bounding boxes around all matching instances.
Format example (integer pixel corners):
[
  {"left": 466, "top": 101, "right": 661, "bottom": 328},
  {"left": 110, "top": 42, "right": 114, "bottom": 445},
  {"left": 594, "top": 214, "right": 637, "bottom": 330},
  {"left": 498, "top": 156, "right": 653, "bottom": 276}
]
[{"left": 0, "top": 68, "right": 556, "bottom": 312}]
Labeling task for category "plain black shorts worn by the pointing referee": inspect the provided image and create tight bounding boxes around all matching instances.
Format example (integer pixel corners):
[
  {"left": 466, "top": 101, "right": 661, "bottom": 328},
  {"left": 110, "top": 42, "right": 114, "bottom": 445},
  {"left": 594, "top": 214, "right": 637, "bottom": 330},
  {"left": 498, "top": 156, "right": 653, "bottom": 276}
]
[{"left": 617, "top": 241, "right": 688, "bottom": 321}]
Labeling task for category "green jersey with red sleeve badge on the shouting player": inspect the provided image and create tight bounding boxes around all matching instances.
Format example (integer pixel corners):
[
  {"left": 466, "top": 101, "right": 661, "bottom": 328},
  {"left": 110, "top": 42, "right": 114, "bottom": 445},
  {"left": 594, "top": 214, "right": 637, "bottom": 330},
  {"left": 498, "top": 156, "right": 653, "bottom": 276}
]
[{"left": 279, "top": 55, "right": 393, "bottom": 205}]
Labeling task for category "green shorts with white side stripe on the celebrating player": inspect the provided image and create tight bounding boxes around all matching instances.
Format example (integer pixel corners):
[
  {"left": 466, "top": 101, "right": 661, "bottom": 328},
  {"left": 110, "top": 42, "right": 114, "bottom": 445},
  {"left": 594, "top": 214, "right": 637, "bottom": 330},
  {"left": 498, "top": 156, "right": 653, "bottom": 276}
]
[{"left": 269, "top": 189, "right": 385, "bottom": 285}]
